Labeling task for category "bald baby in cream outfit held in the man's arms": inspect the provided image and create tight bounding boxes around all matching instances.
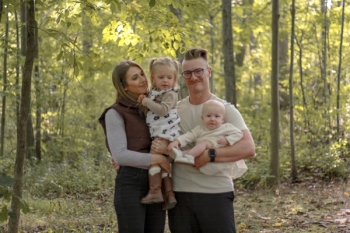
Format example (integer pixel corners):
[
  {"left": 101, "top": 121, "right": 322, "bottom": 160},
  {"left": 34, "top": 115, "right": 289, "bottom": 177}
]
[{"left": 168, "top": 100, "right": 247, "bottom": 178}]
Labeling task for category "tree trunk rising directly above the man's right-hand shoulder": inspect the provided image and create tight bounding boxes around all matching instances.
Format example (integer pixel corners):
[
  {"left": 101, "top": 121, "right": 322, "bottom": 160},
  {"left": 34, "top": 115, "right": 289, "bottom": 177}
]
[{"left": 222, "top": 0, "right": 237, "bottom": 106}]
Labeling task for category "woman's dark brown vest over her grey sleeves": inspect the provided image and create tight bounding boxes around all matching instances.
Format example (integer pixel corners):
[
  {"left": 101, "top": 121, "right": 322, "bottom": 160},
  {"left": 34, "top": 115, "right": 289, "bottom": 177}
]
[{"left": 98, "top": 97, "right": 152, "bottom": 153}]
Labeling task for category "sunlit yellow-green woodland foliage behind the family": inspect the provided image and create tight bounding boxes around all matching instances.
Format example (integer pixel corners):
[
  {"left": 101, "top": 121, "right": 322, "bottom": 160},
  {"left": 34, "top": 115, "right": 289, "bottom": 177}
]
[{"left": 0, "top": 0, "right": 350, "bottom": 228}]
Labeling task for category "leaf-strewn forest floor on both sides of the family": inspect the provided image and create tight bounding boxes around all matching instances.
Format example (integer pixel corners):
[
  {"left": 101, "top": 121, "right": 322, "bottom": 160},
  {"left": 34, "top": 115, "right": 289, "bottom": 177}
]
[{"left": 0, "top": 180, "right": 350, "bottom": 233}]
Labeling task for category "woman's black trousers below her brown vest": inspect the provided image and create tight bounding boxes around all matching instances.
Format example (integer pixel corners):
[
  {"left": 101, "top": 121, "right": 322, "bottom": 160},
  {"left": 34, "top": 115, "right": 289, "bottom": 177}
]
[{"left": 114, "top": 166, "right": 165, "bottom": 233}]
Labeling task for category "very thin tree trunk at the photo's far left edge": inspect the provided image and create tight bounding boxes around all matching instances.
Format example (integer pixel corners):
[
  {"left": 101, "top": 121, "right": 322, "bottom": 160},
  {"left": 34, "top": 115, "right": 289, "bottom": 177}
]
[{"left": 0, "top": 12, "right": 9, "bottom": 158}]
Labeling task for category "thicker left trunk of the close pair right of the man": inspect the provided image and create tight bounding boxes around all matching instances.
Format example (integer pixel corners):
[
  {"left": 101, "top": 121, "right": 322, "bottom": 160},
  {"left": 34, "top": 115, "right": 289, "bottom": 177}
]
[{"left": 268, "top": 0, "right": 280, "bottom": 187}]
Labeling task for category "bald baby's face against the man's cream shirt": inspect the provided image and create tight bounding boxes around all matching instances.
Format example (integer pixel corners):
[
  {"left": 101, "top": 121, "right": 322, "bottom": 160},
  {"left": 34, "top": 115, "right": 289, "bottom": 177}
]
[{"left": 202, "top": 105, "right": 225, "bottom": 130}]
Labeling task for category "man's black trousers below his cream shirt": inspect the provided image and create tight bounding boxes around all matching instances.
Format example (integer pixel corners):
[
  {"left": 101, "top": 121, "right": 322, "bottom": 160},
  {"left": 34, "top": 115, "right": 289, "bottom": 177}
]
[{"left": 168, "top": 192, "right": 236, "bottom": 233}]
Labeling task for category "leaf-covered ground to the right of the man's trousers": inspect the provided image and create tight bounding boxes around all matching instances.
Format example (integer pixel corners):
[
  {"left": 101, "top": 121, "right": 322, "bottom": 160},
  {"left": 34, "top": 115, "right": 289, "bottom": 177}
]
[{"left": 234, "top": 181, "right": 350, "bottom": 233}]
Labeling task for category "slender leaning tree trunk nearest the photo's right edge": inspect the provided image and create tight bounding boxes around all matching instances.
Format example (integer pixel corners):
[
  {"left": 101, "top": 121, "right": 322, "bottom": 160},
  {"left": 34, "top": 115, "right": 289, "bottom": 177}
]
[{"left": 337, "top": 0, "right": 345, "bottom": 138}]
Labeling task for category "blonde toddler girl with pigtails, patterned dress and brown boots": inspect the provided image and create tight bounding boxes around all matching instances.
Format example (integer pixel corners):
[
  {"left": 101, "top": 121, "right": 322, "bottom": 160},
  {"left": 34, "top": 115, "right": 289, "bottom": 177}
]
[{"left": 137, "top": 57, "right": 180, "bottom": 210}]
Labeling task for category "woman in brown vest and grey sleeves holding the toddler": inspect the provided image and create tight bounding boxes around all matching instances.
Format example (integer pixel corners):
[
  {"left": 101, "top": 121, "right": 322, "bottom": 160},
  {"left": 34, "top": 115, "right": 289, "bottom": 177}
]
[{"left": 99, "top": 61, "right": 170, "bottom": 233}]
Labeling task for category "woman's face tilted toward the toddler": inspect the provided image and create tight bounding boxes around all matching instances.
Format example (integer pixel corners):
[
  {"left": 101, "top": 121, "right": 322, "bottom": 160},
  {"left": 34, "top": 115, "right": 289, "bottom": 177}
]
[{"left": 124, "top": 66, "right": 148, "bottom": 99}]
